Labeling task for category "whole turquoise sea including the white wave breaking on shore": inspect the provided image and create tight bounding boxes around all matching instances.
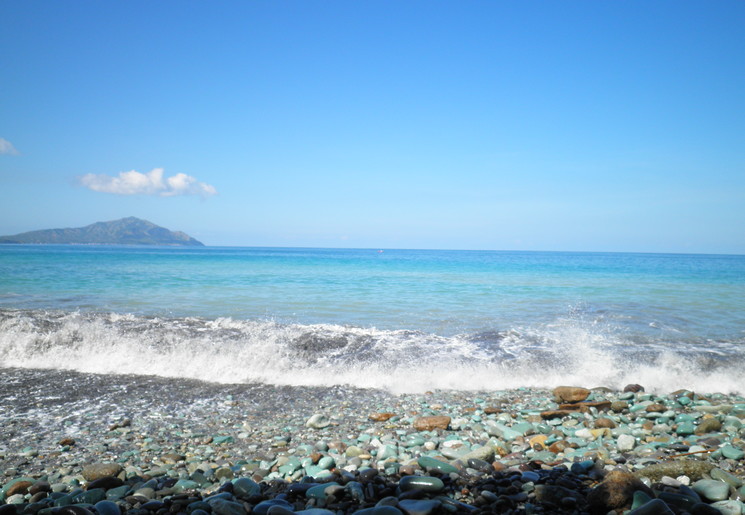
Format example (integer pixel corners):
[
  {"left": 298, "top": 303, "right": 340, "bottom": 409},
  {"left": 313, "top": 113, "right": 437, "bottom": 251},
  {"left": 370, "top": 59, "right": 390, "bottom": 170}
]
[{"left": 0, "top": 245, "right": 745, "bottom": 394}]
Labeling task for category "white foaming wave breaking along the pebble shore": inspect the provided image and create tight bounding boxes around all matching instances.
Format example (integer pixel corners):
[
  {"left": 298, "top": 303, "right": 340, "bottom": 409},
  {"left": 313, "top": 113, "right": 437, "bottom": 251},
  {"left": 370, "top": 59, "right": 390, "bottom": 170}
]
[{"left": 0, "top": 310, "right": 745, "bottom": 393}]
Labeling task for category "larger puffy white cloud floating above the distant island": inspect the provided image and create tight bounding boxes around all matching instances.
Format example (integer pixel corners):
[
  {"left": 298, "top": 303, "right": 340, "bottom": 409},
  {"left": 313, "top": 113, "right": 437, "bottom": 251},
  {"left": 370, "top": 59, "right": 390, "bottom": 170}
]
[{"left": 80, "top": 168, "right": 217, "bottom": 197}]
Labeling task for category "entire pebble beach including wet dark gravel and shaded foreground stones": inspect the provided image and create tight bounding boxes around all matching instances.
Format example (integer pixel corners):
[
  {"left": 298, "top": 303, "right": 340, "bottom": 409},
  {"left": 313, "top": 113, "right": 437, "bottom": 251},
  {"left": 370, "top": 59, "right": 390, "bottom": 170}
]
[{"left": 0, "top": 369, "right": 745, "bottom": 515}]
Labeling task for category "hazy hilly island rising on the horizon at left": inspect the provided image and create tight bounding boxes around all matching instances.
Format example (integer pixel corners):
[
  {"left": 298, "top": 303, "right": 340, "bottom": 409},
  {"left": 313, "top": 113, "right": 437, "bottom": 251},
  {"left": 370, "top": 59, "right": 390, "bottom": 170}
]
[{"left": 0, "top": 216, "right": 204, "bottom": 247}]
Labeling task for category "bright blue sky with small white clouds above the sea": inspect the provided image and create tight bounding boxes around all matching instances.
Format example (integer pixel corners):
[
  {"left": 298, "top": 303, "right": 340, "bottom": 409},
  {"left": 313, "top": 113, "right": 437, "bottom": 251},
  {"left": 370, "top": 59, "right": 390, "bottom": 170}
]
[{"left": 0, "top": 0, "right": 745, "bottom": 254}]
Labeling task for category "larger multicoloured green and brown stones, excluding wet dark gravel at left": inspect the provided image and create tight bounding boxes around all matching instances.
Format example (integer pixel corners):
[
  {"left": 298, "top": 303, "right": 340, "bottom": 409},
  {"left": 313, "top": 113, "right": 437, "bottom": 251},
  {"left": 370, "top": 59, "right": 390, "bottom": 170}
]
[{"left": 0, "top": 385, "right": 745, "bottom": 515}]
